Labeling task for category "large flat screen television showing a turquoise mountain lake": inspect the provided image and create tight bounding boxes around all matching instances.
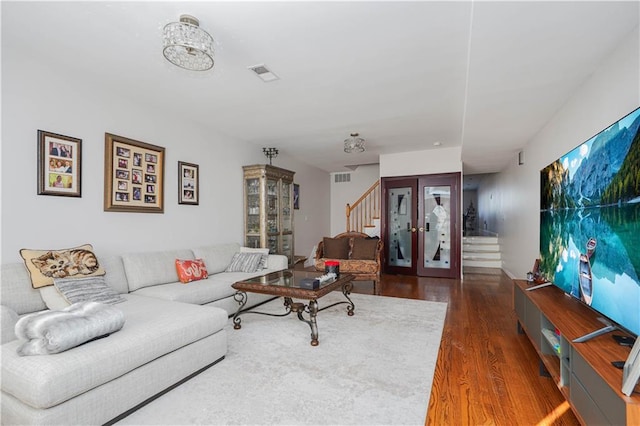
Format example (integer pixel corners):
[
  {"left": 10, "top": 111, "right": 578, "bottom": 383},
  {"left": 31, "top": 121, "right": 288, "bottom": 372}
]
[{"left": 539, "top": 108, "right": 640, "bottom": 336}]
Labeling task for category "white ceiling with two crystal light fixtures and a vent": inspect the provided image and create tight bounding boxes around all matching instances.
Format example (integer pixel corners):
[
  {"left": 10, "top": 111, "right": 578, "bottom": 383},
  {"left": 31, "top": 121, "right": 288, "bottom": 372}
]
[{"left": 2, "top": 1, "right": 640, "bottom": 174}]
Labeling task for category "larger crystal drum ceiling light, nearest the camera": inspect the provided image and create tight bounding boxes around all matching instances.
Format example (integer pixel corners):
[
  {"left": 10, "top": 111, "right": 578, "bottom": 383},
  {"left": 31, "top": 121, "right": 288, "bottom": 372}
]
[{"left": 162, "top": 15, "right": 213, "bottom": 71}]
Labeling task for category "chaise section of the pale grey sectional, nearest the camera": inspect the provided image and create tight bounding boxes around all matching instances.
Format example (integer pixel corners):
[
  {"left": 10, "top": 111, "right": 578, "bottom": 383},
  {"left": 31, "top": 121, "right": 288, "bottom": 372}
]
[{"left": 2, "top": 294, "right": 228, "bottom": 424}]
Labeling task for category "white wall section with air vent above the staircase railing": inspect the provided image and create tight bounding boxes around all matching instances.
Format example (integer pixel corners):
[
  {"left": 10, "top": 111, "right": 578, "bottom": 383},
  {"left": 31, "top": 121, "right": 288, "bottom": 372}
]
[{"left": 330, "top": 164, "right": 380, "bottom": 236}]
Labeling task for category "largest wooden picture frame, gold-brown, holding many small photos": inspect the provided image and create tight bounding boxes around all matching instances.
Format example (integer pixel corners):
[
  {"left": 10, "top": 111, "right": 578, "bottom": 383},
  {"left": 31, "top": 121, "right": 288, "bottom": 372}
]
[{"left": 104, "top": 133, "right": 164, "bottom": 213}]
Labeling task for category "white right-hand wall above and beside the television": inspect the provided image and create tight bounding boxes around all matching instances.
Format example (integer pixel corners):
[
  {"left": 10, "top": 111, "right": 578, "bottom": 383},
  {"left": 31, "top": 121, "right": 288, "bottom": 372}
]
[{"left": 495, "top": 29, "right": 640, "bottom": 278}]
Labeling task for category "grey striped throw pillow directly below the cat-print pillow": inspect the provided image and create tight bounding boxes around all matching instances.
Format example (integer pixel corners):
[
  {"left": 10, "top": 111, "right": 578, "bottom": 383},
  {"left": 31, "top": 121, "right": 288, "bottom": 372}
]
[{"left": 53, "top": 276, "right": 125, "bottom": 305}]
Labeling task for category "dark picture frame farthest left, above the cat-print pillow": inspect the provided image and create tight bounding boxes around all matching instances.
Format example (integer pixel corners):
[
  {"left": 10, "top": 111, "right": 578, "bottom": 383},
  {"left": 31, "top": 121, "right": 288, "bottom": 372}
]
[{"left": 38, "top": 130, "right": 82, "bottom": 197}]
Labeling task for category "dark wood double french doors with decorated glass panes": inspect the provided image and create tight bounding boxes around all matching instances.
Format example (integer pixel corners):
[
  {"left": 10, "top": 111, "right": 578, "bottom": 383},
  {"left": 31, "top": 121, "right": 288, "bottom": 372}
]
[{"left": 381, "top": 173, "right": 461, "bottom": 278}]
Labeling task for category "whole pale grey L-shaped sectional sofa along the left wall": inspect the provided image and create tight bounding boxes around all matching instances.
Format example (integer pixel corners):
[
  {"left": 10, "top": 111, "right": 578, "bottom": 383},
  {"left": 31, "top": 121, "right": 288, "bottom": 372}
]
[{"left": 0, "top": 244, "right": 287, "bottom": 425}]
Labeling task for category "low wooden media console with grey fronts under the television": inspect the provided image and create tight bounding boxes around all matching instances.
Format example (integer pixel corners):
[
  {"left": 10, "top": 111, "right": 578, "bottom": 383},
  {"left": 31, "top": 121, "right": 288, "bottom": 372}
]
[{"left": 513, "top": 280, "right": 640, "bottom": 425}]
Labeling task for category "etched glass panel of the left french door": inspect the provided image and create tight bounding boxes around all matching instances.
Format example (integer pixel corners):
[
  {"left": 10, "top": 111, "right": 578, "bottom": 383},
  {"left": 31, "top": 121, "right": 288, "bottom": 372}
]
[{"left": 387, "top": 187, "right": 415, "bottom": 268}]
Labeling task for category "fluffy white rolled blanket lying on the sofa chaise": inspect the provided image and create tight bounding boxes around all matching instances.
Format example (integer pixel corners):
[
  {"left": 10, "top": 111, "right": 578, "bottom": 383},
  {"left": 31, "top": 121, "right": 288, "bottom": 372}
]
[{"left": 15, "top": 302, "right": 125, "bottom": 356}]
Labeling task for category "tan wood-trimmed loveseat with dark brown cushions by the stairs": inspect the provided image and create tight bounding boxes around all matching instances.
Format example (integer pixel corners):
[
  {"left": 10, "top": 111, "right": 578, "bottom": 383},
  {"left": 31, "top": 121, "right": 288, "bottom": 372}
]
[{"left": 315, "top": 232, "right": 383, "bottom": 293}]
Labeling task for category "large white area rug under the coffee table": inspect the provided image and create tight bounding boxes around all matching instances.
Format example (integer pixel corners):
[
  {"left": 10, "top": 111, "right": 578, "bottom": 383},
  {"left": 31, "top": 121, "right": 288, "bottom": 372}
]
[{"left": 118, "top": 292, "right": 447, "bottom": 425}]
